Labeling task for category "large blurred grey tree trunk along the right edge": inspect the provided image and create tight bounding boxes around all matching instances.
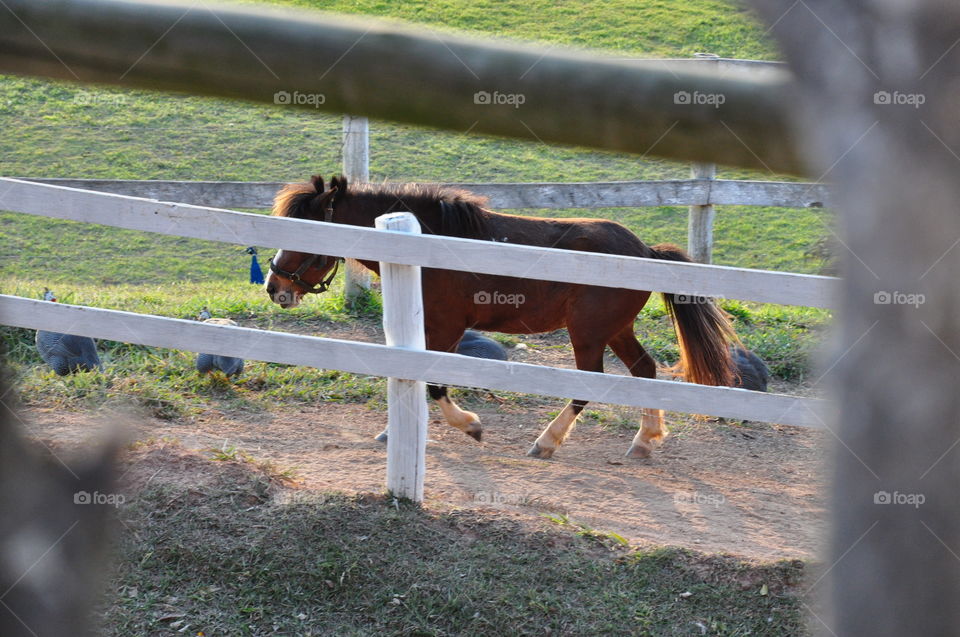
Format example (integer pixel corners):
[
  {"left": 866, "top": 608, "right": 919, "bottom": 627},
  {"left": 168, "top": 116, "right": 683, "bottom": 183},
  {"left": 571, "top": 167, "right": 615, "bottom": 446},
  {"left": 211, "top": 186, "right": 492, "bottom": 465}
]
[{"left": 754, "top": 0, "right": 960, "bottom": 637}]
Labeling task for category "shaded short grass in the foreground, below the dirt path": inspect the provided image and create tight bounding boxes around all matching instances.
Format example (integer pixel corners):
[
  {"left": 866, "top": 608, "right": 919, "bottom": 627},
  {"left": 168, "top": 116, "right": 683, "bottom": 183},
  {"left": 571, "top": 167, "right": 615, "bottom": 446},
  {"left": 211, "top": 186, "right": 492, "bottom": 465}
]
[{"left": 98, "top": 444, "right": 804, "bottom": 636}]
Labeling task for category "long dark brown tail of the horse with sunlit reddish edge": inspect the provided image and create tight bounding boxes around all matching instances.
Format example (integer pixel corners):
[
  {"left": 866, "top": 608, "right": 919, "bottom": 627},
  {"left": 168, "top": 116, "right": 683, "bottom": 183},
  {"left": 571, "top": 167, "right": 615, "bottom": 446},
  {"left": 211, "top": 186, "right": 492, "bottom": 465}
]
[{"left": 651, "top": 243, "right": 740, "bottom": 386}]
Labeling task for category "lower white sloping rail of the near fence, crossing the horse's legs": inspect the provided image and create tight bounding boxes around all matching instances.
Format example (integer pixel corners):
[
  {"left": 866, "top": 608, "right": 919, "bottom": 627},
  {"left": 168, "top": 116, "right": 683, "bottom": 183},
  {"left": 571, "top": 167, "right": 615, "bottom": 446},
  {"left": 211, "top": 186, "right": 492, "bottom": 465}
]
[{"left": 0, "top": 295, "right": 825, "bottom": 427}]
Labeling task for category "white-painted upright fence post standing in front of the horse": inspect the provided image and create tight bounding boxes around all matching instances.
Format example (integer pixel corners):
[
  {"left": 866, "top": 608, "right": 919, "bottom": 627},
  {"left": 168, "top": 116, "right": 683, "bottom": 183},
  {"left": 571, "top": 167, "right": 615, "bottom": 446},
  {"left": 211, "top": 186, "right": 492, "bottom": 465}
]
[{"left": 376, "top": 212, "right": 427, "bottom": 502}]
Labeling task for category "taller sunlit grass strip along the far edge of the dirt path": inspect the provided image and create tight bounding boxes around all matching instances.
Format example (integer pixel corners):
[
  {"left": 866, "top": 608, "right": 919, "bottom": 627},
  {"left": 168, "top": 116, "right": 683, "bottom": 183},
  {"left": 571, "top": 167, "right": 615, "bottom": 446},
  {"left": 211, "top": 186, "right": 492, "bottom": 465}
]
[{"left": 0, "top": 278, "right": 830, "bottom": 419}]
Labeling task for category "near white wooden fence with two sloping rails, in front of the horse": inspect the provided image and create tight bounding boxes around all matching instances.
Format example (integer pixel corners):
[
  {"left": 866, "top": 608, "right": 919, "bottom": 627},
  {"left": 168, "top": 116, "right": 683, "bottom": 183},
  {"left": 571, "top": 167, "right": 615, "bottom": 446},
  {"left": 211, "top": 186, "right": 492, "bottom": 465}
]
[{"left": 0, "top": 179, "right": 836, "bottom": 499}]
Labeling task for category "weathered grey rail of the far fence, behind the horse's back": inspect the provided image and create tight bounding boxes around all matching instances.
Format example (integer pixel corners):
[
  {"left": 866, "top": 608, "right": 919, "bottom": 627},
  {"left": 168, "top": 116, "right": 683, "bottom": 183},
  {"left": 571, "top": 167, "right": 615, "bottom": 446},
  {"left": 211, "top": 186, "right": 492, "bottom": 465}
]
[{"left": 23, "top": 178, "right": 830, "bottom": 209}]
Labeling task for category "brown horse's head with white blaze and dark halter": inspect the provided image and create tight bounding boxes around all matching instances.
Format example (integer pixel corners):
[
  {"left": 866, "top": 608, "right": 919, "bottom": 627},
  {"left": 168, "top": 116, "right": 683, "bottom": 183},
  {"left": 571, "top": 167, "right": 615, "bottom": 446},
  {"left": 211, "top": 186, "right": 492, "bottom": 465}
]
[{"left": 266, "top": 175, "right": 347, "bottom": 309}]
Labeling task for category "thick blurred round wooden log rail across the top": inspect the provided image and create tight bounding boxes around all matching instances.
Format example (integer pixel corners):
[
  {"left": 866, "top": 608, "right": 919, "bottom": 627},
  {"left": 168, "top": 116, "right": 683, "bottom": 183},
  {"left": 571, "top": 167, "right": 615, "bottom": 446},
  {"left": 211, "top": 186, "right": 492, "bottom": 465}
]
[{"left": 0, "top": 0, "right": 807, "bottom": 174}]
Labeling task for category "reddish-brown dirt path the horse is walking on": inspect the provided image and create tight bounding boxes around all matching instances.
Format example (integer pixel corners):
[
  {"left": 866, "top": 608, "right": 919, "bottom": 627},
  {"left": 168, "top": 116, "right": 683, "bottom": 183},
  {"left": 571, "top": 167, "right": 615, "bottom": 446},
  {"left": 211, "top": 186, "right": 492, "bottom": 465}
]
[{"left": 16, "top": 321, "right": 829, "bottom": 559}]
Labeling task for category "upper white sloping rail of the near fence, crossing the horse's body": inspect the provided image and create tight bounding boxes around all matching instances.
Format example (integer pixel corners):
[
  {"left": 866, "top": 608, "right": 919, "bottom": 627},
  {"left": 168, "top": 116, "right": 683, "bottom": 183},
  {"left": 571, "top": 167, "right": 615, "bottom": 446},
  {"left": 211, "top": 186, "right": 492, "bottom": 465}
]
[{"left": 0, "top": 178, "right": 838, "bottom": 307}]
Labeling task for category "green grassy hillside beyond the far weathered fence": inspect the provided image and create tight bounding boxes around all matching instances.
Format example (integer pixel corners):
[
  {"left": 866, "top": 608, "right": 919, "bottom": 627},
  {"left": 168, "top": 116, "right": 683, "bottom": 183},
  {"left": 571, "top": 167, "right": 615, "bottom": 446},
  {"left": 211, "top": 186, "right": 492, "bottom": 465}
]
[{"left": 0, "top": 0, "right": 829, "bottom": 284}]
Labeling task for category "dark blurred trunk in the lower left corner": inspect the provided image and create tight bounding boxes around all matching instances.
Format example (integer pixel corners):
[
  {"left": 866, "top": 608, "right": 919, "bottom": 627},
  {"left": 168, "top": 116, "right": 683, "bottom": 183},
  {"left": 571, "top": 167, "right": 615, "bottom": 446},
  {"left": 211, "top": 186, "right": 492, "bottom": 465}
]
[{"left": 0, "top": 370, "right": 118, "bottom": 637}]
